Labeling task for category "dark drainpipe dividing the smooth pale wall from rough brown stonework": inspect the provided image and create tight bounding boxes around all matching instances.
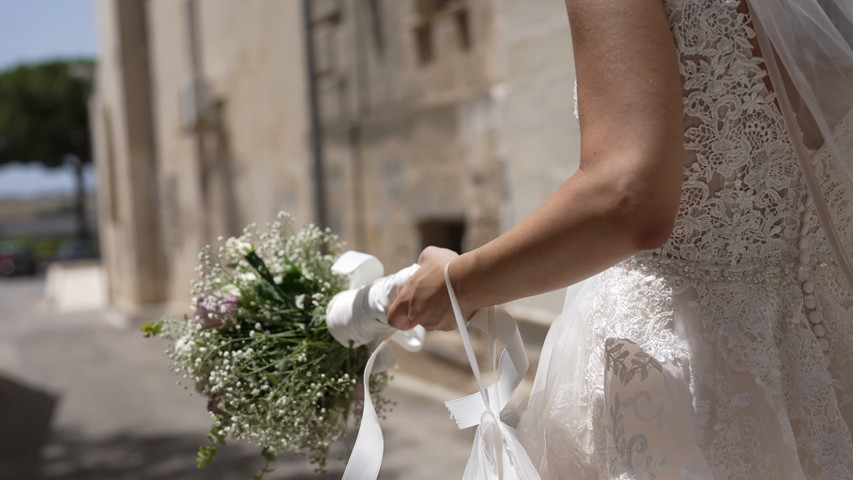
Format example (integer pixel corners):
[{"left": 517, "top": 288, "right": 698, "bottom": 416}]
[{"left": 302, "top": 0, "right": 329, "bottom": 229}]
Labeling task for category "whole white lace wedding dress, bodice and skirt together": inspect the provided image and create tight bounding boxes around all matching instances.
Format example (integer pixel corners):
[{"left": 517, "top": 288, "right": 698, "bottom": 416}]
[{"left": 518, "top": 0, "right": 853, "bottom": 480}]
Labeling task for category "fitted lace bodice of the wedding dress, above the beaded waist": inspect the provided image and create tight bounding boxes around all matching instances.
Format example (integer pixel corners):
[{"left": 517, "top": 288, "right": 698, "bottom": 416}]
[{"left": 651, "top": 0, "right": 804, "bottom": 267}]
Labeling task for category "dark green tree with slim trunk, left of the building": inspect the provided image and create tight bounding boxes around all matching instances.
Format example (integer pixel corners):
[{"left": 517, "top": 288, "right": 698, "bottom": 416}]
[{"left": 0, "top": 60, "right": 94, "bottom": 237}]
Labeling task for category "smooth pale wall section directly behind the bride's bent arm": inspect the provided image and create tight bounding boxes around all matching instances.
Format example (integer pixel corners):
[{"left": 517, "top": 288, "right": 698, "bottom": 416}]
[{"left": 495, "top": 0, "right": 580, "bottom": 322}]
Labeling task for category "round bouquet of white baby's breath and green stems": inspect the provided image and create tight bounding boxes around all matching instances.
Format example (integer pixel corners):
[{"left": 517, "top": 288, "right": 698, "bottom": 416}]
[{"left": 143, "top": 213, "right": 389, "bottom": 478}]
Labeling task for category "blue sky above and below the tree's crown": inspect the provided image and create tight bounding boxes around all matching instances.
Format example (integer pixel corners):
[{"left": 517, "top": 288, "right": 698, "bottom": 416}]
[{"left": 0, "top": 0, "right": 97, "bottom": 197}]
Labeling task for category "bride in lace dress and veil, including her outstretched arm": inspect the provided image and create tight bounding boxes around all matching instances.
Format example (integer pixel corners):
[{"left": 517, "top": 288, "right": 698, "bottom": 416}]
[{"left": 389, "top": 0, "right": 853, "bottom": 479}]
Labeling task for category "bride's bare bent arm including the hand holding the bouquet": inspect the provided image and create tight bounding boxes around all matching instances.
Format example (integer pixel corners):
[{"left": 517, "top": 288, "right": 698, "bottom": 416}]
[{"left": 389, "top": 0, "right": 684, "bottom": 330}]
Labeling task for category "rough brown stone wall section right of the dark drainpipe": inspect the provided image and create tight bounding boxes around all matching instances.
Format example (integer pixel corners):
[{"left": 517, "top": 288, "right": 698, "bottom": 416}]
[{"left": 314, "top": 0, "right": 501, "bottom": 269}]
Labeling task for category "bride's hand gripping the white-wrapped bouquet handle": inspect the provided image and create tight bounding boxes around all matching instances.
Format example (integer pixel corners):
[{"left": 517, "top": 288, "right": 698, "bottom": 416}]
[{"left": 388, "top": 247, "right": 472, "bottom": 331}]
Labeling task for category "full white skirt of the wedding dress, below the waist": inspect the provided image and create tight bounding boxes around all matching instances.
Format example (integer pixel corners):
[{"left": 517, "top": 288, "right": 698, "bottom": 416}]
[{"left": 518, "top": 258, "right": 853, "bottom": 480}]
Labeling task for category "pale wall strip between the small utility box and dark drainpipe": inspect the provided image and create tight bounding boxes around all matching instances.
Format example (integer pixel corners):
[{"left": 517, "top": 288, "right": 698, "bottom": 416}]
[{"left": 191, "top": 0, "right": 314, "bottom": 228}]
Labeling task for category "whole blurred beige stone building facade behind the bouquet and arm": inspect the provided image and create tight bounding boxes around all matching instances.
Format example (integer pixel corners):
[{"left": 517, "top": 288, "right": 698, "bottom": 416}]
[{"left": 91, "top": 0, "right": 578, "bottom": 319}]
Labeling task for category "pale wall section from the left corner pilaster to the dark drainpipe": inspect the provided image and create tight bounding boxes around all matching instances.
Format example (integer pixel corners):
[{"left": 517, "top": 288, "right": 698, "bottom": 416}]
[{"left": 148, "top": 0, "right": 313, "bottom": 306}]
